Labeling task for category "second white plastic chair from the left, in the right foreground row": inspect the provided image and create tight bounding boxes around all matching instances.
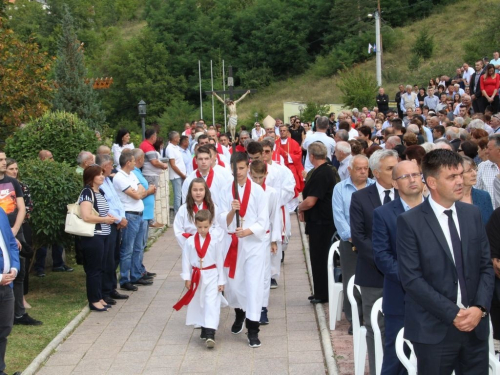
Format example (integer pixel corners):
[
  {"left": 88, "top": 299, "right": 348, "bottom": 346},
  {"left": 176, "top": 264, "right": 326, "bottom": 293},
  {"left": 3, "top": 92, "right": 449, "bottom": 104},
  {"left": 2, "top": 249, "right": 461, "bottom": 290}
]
[{"left": 347, "top": 276, "right": 366, "bottom": 375}]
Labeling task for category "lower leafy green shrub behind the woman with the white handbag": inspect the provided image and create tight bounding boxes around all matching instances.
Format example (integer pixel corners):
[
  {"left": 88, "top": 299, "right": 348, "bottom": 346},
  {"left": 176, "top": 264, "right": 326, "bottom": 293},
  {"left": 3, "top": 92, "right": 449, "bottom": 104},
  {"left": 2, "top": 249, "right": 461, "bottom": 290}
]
[{"left": 19, "top": 159, "right": 83, "bottom": 248}]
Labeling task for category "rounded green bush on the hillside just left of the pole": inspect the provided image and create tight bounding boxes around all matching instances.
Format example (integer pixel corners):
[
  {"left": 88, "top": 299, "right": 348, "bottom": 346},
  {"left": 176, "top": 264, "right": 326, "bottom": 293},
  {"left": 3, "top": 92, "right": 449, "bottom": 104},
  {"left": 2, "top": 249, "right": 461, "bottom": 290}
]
[{"left": 337, "top": 69, "right": 378, "bottom": 108}]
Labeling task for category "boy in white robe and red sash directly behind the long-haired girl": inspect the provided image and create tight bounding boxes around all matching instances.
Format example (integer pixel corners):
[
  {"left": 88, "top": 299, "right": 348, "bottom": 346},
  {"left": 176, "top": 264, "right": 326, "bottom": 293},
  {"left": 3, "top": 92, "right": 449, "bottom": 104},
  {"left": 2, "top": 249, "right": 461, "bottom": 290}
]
[{"left": 182, "top": 146, "right": 227, "bottom": 207}]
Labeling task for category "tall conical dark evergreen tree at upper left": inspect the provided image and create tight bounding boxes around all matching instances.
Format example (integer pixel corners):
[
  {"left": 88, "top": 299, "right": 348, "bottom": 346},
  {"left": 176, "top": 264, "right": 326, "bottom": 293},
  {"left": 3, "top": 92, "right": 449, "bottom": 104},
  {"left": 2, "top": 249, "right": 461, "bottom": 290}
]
[{"left": 53, "top": 7, "right": 105, "bottom": 129}]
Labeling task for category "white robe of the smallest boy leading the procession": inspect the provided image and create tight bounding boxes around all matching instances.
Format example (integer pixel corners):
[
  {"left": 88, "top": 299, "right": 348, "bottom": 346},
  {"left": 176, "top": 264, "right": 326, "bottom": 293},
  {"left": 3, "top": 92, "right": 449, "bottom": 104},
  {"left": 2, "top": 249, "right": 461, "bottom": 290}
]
[{"left": 181, "top": 228, "right": 226, "bottom": 329}]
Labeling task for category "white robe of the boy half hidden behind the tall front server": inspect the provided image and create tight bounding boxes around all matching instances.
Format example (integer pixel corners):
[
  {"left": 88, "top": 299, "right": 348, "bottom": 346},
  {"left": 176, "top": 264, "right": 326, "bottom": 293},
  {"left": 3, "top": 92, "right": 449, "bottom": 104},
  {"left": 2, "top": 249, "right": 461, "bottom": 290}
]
[{"left": 262, "top": 186, "right": 281, "bottom": 307}]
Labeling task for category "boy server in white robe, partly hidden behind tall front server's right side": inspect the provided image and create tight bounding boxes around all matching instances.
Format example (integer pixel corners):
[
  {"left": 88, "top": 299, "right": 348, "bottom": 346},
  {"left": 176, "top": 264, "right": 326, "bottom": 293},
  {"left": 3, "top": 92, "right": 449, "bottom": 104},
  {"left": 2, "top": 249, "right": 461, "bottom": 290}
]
[{"left": 250, "top": 160, "right": 281, "bottom": 325}]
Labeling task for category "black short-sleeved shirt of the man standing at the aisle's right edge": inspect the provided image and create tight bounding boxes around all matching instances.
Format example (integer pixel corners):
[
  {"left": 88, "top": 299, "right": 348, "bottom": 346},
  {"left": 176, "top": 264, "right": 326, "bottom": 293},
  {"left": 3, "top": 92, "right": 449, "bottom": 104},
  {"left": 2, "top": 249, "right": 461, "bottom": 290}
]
[{"left": 302, "top": 163, "right": 335, "bottom": 224}]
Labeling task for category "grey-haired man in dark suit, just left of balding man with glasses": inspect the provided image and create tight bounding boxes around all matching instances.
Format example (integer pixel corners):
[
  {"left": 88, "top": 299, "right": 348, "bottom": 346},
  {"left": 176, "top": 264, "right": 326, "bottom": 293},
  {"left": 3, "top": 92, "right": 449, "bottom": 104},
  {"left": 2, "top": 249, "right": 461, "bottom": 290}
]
[{"left": 349, "top": 150, "right": 398, "bottom": 375}]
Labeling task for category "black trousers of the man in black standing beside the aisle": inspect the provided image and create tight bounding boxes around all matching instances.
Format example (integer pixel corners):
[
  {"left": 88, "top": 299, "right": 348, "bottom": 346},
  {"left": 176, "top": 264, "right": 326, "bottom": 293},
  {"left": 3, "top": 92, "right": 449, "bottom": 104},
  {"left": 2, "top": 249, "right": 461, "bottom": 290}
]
[{"left": 307, "top": 222, "right": 335, "bottom": 299}]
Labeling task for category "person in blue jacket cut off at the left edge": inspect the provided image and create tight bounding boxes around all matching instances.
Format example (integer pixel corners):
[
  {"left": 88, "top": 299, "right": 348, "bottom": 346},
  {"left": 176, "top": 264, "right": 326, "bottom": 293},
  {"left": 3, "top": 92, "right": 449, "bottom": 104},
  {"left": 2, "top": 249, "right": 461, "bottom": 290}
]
[{"left": 0, "top": 208, "right": 20, "bottom": 375}]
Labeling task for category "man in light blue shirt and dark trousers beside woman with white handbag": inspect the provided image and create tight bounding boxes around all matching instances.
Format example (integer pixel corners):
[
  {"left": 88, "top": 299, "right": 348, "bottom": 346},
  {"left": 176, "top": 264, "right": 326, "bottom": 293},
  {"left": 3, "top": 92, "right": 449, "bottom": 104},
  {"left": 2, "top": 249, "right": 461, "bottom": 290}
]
[{"left": 96, "top": 154, "right": 128, "bottom": 305}]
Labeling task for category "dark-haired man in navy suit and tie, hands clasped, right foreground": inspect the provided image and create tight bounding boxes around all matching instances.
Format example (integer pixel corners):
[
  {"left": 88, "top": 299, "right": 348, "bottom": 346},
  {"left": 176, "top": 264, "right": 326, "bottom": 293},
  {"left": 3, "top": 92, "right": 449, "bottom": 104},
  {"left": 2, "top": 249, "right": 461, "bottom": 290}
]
[{"left": 396, "top": 150, "right": 494, "bottom": 375}]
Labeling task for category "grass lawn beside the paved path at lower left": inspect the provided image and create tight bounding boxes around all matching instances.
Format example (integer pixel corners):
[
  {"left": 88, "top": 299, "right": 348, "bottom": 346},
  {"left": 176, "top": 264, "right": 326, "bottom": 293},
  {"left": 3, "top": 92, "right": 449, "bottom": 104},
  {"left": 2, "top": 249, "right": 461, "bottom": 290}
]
[{"left": 6, "top": 257, "right": 87, "bottom": 373}]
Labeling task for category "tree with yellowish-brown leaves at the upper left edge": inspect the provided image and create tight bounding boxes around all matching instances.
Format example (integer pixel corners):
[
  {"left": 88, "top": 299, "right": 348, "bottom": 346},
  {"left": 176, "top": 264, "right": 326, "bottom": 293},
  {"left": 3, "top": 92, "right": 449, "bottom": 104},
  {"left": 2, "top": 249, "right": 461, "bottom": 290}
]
[{"left": 0, "top": 3, "right": 52, "bottom": 142}]
